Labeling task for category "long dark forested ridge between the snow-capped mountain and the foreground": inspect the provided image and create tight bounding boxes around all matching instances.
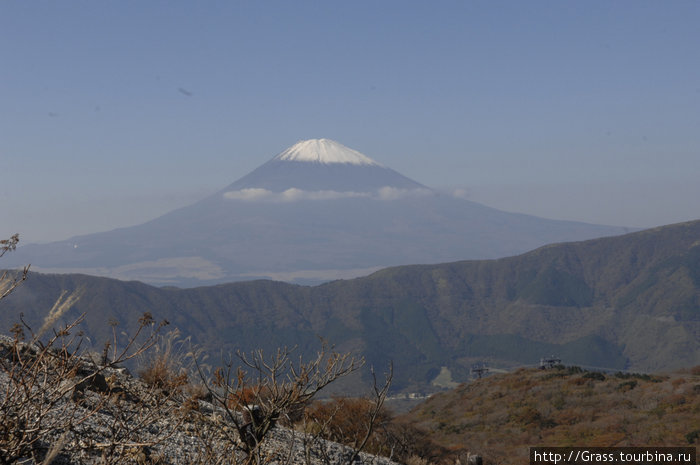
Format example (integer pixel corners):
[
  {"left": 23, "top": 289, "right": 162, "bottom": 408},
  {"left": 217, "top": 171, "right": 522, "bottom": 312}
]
[{"left": 0, "top": 221, "right": 700, "bottom": 391}]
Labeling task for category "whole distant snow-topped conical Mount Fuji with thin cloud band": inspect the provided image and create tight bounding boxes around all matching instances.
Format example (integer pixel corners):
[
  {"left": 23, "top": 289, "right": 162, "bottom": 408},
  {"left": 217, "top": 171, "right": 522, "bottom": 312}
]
[{"left": 3, "top": 139, "right": 626, "bottom": 286}]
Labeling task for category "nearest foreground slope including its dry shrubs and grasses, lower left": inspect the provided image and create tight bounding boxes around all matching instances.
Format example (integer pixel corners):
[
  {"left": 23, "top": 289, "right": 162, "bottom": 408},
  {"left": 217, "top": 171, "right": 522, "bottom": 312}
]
[{"left": 0, "top": 334, "right": 396, "bottom": 465}]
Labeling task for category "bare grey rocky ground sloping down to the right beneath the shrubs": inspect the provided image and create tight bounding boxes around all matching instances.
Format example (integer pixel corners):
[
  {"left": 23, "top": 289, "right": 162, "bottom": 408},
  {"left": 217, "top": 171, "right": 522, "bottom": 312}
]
[{"left": 0, "top": 336, "right": 394, "bottom": 465}]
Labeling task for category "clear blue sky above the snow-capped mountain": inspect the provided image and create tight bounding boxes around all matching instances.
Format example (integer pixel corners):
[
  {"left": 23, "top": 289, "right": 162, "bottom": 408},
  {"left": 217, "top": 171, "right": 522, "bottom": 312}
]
[{"left": 0, "top": 0, "right": 700, "bottom": 242}]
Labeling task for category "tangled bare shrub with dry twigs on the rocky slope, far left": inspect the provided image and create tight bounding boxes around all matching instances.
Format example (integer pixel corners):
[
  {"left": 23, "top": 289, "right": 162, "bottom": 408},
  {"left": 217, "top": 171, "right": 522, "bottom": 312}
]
[{"left": 0, "top": 291, "right": 172, "bottom": 464}]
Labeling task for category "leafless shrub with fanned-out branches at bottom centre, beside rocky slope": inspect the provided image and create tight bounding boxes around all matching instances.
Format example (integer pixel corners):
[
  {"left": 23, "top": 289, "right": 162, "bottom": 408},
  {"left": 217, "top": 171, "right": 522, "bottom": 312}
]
[{"left": 193, "top": 343, "right": 391, "bottom": 464}]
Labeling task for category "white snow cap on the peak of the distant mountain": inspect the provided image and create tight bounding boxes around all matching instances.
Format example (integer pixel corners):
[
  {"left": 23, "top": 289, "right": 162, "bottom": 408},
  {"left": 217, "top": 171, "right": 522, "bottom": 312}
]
[{"left": 274, "top": 139, "right": 381, "bottom": 166}]
